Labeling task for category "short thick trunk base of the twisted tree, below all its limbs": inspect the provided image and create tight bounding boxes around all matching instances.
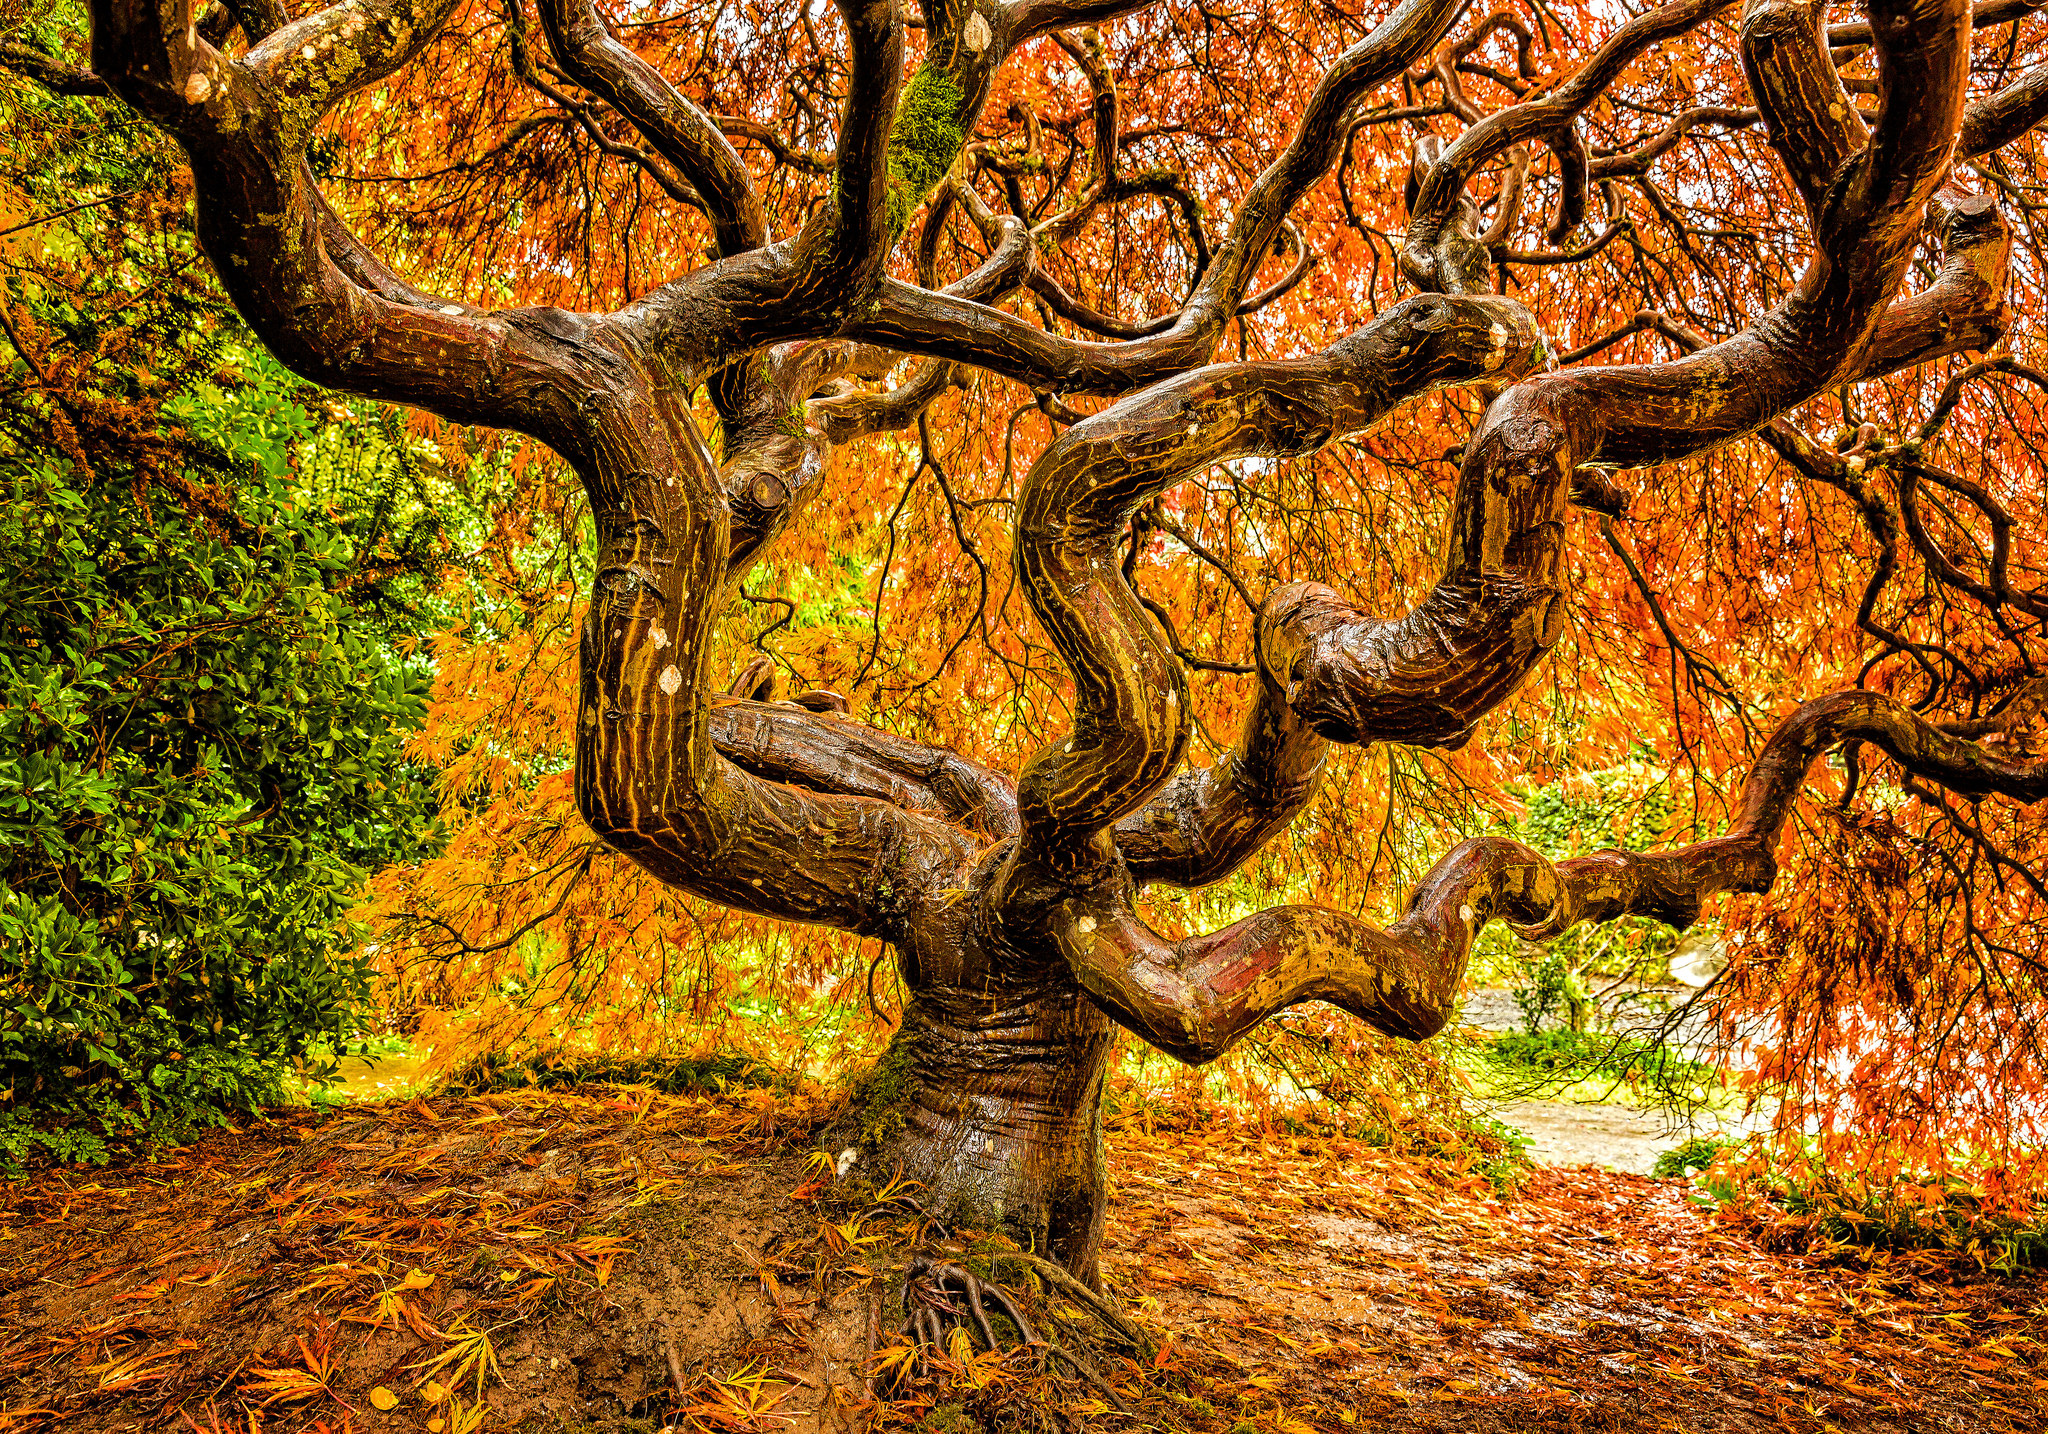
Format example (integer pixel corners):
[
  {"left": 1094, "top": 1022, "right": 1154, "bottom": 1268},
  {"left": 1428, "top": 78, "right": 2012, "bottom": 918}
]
[{"left": 821, "top": 963, "right": 1116, "bottom": 1284}]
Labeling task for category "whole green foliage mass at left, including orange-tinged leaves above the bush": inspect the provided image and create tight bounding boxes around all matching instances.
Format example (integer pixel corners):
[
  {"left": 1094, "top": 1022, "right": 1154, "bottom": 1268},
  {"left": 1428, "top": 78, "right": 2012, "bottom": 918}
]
[{"left": 0, "top": 61, "right": 466, "bottom": 1176}]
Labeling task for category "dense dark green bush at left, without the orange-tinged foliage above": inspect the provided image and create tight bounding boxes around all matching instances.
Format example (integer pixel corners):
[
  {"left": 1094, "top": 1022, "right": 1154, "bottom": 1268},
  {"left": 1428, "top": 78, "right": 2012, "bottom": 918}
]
[{"left": 0, "top": 436, "right": 444, "bottom": 1157}]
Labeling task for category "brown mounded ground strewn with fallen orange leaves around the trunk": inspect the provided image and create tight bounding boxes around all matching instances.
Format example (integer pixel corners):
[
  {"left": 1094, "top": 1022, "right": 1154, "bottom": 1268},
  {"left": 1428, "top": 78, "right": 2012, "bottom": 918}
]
[{"left": 0, "top": 1088, "right": 2048, "bottom": 1434}]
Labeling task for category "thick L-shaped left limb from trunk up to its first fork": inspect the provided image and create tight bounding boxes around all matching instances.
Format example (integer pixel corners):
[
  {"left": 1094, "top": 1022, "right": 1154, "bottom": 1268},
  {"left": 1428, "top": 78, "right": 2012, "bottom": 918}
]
[{"left": 575, "top": 391, "right": 977, "bottom": 940}]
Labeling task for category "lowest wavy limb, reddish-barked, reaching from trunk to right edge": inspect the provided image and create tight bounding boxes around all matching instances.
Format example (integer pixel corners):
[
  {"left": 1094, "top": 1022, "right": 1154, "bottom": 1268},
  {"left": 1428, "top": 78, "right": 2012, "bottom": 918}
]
[{"left": 1053, "top": 690, "right": 2048, "bottom": 1063}]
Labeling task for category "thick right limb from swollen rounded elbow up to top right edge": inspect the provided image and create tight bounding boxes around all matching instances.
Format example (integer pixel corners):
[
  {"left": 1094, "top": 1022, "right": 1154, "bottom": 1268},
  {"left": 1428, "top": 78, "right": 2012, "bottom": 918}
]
[{"left": 1212, "top": 0, "right": 2003, "bottom": 762}]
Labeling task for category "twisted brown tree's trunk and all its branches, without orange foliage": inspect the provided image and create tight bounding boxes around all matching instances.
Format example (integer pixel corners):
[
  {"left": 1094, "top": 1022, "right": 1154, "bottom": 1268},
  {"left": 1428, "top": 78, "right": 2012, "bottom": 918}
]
[{"left": 16, "top": 0, "right": 2048, "bottom": 1274}]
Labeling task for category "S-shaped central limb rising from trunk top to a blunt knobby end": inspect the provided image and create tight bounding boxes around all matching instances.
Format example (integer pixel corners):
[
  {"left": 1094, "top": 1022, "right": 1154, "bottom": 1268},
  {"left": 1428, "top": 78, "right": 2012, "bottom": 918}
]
[{"left": 991, "top": 297, "right": 1540, "bottom": 926}]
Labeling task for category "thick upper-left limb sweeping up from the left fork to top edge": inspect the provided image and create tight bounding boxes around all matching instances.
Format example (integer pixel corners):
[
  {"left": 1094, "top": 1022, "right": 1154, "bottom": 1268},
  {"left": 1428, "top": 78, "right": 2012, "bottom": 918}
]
[{"left": 92, "top": 0, "right": 623, "bottom": 453}]
